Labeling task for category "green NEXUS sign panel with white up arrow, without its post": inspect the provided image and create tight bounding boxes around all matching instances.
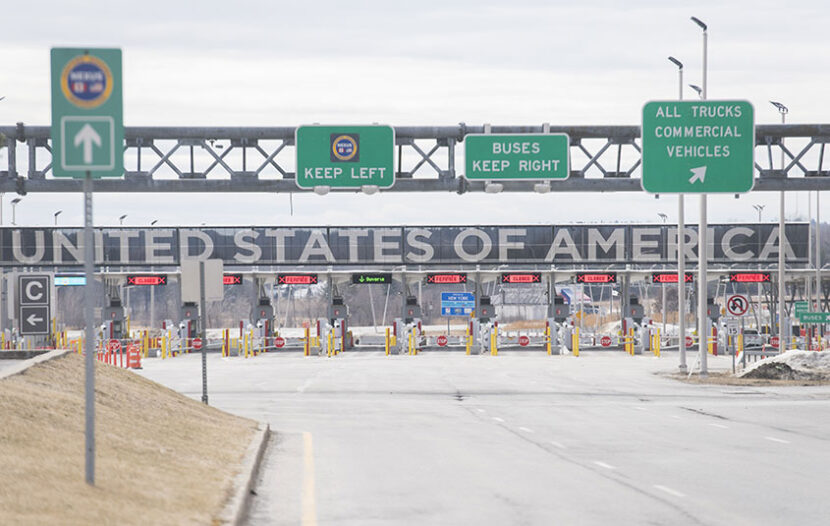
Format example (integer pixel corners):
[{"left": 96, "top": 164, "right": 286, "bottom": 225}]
[{"left": 51, "top": 48, "right": 124, "bottom": 179}]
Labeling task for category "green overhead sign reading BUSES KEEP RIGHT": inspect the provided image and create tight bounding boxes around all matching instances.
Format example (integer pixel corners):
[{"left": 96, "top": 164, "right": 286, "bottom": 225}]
[{"left": 464, "top": 133, "right": 570, "bottom": 180}]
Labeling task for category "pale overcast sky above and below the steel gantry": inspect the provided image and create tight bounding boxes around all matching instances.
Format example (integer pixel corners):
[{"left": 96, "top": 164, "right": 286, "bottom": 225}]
[{"left": 0, "top": 0, "right": 830, "bottom": 226}]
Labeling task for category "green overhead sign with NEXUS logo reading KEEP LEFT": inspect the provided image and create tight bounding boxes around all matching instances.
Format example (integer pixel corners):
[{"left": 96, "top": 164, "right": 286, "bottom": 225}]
[{"left": 296, "top": 125, "right": 395, "bottom": 189}]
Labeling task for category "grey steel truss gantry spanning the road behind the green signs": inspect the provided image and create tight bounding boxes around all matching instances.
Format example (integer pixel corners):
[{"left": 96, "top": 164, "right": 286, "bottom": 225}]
[{"left": 0, "top": 123, "right": 830, "bottom": 194}]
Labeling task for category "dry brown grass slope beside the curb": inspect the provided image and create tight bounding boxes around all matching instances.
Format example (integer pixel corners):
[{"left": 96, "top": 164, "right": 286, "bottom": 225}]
[{"left": 0, "top": 354, "right": 256, "bottom": 525}]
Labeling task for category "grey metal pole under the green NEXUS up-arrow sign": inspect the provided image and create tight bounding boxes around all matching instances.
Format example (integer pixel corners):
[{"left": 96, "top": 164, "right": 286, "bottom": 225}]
[{"left": 83, "top": 171, "right": 95, "bottom": 486}]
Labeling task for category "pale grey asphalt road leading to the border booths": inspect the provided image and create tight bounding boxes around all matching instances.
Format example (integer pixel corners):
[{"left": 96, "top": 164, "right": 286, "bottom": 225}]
[{"left": 142, "top": 352, "right": 830, "bottom": 525}]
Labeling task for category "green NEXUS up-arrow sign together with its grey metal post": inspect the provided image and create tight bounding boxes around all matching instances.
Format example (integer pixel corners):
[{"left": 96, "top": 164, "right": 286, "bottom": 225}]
[{"left": 51, "top": 48, "right": 124, "bottom": 485}]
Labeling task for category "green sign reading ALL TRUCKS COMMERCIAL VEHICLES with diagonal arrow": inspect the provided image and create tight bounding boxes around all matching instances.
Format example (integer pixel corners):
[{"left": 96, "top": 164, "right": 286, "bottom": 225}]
[{"left": 642, "top": 100, "right": 755, "bottom": 194}]
